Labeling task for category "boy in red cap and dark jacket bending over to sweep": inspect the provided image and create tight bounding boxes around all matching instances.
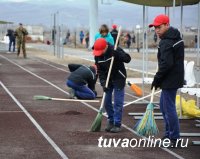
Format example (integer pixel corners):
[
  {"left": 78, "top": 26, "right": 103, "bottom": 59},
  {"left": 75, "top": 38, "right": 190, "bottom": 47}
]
[{"left": 93, "top": 38, "right": 131, "bottom": 133}]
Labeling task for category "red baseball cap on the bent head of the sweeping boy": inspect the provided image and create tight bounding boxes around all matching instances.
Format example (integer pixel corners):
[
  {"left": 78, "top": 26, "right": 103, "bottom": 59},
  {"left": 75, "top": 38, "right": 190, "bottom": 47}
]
[{"left": 93, "top": 38, "right": 107, "bottom": 56}]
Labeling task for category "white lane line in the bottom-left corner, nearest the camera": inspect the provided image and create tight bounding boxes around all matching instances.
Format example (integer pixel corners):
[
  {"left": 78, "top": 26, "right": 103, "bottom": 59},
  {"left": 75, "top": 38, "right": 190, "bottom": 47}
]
[{"left": 0, "top": 81, "right": 68, "bottom": 159}]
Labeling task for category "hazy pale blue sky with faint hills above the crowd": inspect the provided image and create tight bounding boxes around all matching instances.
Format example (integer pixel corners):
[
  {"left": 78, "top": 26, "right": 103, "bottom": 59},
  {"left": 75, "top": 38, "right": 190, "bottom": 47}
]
[{"left": 0, "top": 0, "right": 198, "bottom": 29}]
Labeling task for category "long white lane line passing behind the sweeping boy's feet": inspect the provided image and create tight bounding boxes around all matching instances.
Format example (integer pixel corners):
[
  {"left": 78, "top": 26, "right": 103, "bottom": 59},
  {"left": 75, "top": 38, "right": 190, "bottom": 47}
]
[{"left": 0, "top": 55, "right": 184, "bottom": 159}]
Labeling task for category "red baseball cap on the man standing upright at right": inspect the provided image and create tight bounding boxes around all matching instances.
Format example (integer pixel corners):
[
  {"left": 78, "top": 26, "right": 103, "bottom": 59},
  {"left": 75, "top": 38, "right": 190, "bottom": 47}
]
[{"left": 149, "top": 14, "right": 169, "bottom": 28}]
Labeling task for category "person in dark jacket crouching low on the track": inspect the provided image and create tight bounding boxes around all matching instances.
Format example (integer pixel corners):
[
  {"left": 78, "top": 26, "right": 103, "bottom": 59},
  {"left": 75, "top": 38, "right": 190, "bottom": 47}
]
[{"left": 66, "top": 64, "right": 97, "bottom": 99}]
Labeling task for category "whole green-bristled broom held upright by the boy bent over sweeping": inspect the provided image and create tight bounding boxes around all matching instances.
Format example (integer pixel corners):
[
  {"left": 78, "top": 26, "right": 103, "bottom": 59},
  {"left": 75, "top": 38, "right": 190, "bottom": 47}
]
[{"left": 90, "top": 26, "right": 121, "bottom": 132}]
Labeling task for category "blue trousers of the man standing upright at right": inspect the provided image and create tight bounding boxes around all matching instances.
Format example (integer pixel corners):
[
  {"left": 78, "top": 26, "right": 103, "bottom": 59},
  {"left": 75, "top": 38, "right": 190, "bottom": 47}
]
[{"left": 160, "top": 89, "right": 180, "bottom": 139}]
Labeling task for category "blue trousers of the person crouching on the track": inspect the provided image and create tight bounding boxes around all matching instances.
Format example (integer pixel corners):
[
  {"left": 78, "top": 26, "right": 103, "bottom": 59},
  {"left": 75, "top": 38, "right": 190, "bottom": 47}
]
[{"left": 66, "top": 80, "right": 96, "bottom": 99}]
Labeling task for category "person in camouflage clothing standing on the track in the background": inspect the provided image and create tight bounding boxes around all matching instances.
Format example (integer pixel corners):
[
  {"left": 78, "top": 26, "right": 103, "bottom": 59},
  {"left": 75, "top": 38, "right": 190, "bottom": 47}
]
[{"left": 15, "top": 23, "right": 28, "bottom": 58}]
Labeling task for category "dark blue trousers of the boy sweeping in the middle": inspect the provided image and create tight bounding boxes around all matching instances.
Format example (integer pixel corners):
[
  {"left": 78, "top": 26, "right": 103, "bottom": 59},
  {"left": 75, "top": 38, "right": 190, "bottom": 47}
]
[{"left": 104, "top": 86, "right": 124, "bottom": 127}]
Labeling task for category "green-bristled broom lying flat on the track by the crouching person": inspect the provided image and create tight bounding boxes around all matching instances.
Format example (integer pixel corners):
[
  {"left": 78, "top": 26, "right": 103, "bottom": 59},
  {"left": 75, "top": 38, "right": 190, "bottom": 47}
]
[{"left": 33, "top": 95, "right": 99, "bottom": 102}]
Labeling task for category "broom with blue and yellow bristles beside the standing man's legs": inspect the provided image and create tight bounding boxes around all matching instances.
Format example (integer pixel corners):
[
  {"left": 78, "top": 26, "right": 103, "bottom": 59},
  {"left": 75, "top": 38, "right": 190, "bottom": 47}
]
[{"left": 133, "top": 87, "right": 159, "bottom": 136}]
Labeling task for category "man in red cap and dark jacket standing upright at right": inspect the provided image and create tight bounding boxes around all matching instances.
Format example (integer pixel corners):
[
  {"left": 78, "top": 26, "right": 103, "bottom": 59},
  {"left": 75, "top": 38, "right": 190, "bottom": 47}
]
[{"left": 149, "top": 15, "right": 184, "bottom": 147}]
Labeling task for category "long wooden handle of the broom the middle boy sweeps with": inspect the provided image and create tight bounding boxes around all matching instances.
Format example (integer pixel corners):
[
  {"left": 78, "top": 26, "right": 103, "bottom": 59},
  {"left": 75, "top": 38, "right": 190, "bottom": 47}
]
[{"left": 100, "top": 26, "right": 121, "bottom": 110}]
